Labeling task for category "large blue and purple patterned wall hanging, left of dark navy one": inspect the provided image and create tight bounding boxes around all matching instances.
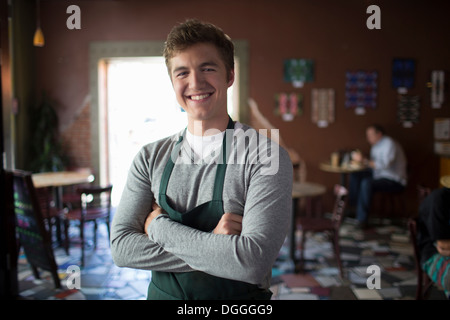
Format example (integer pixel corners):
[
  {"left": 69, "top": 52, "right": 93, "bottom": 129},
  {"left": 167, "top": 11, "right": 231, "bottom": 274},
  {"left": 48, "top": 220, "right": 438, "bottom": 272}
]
[{"left": 345, "top": 71, "right": 378, "bottom": 115}]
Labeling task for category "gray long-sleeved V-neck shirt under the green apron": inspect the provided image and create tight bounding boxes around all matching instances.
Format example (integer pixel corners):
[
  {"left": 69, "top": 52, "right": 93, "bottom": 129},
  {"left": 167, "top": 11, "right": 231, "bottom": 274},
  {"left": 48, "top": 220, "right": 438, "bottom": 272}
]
[{"left": 111, "top": 123, "right": 293, "bottom": 289}]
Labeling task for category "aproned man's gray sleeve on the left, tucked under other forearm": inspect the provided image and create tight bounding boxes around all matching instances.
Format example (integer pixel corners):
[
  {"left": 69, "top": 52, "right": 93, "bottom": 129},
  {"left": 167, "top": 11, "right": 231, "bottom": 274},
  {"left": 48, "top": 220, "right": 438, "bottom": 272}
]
[{"left": 111, "top": 150, "right": 193, "bottom": 272}]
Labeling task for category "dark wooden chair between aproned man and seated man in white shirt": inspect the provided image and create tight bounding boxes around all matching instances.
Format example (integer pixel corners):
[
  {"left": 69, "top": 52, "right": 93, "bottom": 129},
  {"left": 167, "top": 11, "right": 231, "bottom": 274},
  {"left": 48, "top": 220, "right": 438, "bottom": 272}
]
[{"left": 297, "top": 184, "right": 348, "bottom": 278}]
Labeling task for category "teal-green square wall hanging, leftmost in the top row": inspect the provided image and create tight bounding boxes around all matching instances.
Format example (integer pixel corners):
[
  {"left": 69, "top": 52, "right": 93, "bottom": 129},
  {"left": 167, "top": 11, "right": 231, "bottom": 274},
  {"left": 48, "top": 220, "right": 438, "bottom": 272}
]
[{"left": 284, "top": 59, "right": 314, "bottom": 88}]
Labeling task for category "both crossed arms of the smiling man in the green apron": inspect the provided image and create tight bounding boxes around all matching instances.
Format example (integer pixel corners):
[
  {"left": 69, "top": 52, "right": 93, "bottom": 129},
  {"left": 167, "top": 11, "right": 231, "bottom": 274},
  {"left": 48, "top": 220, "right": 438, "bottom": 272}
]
[{"left": 111, "top": 146, "right": 292, "bottom": 284}]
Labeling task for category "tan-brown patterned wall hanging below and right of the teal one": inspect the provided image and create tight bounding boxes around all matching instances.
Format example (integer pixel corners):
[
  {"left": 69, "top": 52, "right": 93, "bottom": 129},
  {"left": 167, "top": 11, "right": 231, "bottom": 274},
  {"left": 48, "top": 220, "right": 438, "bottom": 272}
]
[{"left": 311, "top": 89, "right": 334, "bottom": 128}]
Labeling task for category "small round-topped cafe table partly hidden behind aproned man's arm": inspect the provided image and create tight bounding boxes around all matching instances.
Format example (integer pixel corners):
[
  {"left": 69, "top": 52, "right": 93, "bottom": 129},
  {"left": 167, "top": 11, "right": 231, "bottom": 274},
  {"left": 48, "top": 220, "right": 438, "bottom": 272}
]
[{"left": 289, "top": 181, "right": 327, "bottom": 265}]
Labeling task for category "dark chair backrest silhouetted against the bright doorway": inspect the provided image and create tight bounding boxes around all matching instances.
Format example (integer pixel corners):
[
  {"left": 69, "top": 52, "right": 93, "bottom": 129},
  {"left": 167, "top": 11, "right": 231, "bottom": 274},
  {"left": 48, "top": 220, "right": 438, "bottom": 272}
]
[{"left": 77, "top": 184, "right": 113, "bottom": 215}]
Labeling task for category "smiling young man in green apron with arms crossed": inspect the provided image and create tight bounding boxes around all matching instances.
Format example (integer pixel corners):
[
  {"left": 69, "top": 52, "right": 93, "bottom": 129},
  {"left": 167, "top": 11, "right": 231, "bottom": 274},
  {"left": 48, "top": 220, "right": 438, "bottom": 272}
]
[{"left": 111, "top": 20, "right": 293, "bottom": 299}]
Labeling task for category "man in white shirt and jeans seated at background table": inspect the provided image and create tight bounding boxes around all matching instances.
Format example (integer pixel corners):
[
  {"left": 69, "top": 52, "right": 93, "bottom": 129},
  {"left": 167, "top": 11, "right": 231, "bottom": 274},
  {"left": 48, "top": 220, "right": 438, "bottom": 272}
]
[{"left": 349, "top": 124, "right": 407, "bottom": 228}]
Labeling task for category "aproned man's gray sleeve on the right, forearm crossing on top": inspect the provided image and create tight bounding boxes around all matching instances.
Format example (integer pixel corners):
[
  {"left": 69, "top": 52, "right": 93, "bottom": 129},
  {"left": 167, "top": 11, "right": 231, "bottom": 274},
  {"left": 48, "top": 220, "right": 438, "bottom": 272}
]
[{"left": 147, "top": 144, "right": 293, "bottom": 284}]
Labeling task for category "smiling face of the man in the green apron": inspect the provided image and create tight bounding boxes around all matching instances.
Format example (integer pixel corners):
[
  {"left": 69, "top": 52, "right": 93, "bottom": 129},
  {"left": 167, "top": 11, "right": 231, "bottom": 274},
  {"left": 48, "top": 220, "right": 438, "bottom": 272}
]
[{"left": 169, "top": 43, "right": 234, "bottom": 125}]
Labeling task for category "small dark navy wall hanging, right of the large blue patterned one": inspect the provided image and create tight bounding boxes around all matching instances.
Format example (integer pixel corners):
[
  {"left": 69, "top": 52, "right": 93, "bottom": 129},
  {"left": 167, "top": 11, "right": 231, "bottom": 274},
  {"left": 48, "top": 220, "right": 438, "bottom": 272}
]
[{"left": 392, "top": 58, "right": 416, "bottom": 94}]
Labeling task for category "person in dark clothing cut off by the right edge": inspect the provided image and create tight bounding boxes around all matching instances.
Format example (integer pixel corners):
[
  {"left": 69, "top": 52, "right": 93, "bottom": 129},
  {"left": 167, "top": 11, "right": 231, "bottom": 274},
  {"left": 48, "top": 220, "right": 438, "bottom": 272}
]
[{"left": 417, "top": 183, "right": 450, "bottom": 299}]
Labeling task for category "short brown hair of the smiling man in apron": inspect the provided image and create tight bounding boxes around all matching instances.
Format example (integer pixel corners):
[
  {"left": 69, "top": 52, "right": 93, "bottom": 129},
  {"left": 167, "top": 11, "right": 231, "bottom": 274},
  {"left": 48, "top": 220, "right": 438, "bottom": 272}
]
[{"left": 164, "top": 19, "right": 234, "bottom": 79}]
